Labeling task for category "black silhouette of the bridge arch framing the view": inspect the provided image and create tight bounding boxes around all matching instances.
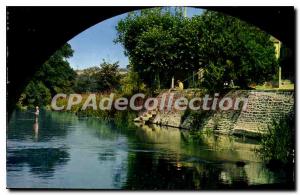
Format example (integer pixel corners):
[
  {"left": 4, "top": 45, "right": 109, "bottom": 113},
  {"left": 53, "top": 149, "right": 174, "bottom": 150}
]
[{"left": 6, "top": 7, "right": 295, "bottom": 116}]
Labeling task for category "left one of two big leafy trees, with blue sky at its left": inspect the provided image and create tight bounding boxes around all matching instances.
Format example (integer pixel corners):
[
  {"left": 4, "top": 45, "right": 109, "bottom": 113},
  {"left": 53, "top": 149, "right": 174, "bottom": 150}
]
[{"left": 116, "top": 8, "right": 199, "bottom": 88}]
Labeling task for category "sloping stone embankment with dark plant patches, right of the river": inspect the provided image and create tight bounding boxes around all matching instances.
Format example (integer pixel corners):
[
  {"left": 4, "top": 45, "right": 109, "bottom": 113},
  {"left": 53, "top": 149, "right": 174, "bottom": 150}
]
[{"left": 137, "top": 90, "right": 295, "bottom": 137}]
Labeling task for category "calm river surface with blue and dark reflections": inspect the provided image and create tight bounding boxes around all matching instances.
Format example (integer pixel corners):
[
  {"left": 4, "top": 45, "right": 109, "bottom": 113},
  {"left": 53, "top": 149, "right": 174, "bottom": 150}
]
[{"left": 7, "top": 112, "right": 290, "bottom": 190}]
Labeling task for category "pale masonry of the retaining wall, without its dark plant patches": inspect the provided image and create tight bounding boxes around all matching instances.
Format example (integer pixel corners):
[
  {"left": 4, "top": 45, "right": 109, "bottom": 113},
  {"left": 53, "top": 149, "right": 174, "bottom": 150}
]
[{"left": 149, "top": 90, "right": 294, "bottom": 135}]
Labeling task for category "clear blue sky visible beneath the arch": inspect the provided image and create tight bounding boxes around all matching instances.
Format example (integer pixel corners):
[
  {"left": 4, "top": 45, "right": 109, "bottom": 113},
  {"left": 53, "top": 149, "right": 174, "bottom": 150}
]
[{"left": 68, "top": 7, "right": 203, "bottom": 70}]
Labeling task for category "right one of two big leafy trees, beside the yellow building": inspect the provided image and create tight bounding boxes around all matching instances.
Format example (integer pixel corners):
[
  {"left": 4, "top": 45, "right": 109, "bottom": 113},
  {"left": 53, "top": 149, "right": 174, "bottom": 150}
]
[{"left": 194, "top": 11, "right": 278, "bottom": 89}]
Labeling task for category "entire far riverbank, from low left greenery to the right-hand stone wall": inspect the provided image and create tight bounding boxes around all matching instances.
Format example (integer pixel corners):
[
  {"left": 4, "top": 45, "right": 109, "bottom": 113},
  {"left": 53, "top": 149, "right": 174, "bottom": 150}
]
[{"left": 48, "top": 89, "right": 294, "bottom": 137}]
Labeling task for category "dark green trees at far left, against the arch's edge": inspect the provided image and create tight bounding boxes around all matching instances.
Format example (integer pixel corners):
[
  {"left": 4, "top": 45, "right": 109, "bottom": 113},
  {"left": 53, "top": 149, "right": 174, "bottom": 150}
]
[{"left": 18, "top": 44, "right": 76, "bottom": 107}]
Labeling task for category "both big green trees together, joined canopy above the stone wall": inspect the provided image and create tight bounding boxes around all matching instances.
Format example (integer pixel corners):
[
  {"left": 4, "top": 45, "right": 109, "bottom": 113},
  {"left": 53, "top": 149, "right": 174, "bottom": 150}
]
[{"left": 116, "top": 8, "right": 277, "bottom": 90}]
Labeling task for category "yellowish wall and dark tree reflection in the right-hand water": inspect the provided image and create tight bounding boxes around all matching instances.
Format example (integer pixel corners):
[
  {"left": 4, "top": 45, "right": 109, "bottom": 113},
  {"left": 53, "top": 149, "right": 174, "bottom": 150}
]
[{"left": 125, "top": 125, "right": 288, "bottom": 189}]
